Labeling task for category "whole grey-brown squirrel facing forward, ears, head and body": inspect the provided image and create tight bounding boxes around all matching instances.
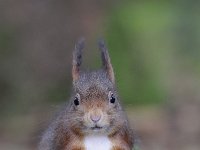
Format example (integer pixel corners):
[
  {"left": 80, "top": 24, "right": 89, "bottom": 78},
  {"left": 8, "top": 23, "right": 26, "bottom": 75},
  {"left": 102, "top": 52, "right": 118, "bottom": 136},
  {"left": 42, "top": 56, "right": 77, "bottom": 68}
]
[{"left": 39, "top": 39, "right": 135, "bottom": 150}]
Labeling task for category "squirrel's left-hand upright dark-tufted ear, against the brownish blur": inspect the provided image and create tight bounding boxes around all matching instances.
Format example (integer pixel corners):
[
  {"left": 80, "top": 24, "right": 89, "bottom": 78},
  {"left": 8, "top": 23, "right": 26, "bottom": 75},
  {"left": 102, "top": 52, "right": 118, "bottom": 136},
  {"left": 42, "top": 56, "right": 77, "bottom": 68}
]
[{"left": 72, "top": 38, "right": 85, "bottom": 81}]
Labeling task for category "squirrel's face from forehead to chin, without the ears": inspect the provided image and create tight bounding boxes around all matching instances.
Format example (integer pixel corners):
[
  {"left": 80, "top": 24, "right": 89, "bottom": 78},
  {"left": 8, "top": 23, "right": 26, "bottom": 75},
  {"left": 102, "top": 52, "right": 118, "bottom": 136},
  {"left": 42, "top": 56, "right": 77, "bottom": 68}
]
[{"left": 71, "top": 70, "right": 123, "bottom": 134}]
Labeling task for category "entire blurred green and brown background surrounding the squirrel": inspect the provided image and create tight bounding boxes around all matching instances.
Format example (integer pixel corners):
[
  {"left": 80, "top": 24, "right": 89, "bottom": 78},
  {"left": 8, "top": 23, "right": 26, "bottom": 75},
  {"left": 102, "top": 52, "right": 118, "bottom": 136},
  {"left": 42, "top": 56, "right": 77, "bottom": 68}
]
[{"left": 0, "top": 0, "right": 200, "bottom": 150}]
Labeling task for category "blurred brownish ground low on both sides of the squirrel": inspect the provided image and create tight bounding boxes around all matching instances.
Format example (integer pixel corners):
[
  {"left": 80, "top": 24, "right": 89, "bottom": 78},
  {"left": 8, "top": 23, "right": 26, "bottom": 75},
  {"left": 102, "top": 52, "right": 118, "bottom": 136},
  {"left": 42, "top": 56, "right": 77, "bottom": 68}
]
[{"left": 0, "top": 104, "right": 200, "bottom": 150}]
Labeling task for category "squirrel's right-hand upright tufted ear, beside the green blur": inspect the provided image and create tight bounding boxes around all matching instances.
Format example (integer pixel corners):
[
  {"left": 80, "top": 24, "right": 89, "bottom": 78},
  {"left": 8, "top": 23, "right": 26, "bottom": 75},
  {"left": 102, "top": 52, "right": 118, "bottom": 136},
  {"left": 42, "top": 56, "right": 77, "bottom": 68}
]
[{"left": 99, "top": 39, "right": 115, "bottom": 83}]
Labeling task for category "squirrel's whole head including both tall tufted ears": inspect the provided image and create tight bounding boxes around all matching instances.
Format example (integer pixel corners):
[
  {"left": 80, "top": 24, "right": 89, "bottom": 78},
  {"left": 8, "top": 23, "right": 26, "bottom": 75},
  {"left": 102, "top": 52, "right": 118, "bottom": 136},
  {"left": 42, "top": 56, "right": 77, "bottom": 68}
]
[{"left": 70, "top": 39, "right": 126, "bottom": 135}]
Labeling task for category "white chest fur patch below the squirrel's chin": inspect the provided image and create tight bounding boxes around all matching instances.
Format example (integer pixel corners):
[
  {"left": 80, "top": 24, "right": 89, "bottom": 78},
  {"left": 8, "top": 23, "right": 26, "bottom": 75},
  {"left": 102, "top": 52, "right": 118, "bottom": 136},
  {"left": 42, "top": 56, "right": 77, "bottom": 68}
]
[{"left": 84, "top": 135, "right": 112, "bottom": 150}]
